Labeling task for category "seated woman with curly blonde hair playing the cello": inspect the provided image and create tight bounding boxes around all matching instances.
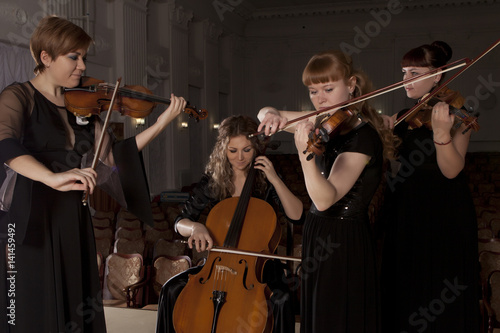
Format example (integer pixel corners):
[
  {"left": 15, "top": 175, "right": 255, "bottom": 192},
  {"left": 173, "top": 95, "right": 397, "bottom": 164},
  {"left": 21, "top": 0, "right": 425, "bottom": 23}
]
[{"left": 157, "top": 116, "right": 303, "bottom": 333}]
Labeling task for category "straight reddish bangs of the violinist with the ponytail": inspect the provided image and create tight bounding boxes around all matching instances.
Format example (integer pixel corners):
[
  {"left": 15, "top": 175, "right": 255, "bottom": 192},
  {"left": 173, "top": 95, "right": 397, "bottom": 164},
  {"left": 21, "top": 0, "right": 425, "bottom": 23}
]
[{"left": 302, "top": 55, "right": 345, "bottom": 86}]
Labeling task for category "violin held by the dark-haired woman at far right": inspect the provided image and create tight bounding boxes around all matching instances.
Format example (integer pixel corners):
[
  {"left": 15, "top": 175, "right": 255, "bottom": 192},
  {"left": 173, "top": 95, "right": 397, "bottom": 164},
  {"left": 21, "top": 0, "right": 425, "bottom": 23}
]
[{"left": 394, "top": 86, "right": 479, "bottom": 134}]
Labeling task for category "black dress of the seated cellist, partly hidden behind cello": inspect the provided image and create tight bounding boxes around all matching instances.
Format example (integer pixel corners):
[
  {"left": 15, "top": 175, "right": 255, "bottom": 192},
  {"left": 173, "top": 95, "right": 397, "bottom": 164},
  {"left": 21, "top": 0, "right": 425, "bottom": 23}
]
[{"left": 156, "top": 174, "right": 303, "bottom": 333}]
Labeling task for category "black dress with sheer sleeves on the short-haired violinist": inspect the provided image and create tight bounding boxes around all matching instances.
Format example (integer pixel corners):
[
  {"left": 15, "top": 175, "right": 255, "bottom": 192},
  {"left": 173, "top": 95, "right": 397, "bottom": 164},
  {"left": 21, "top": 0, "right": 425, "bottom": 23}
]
[{"left": 0, "top": 82, "right": 152, "bottom": 333}]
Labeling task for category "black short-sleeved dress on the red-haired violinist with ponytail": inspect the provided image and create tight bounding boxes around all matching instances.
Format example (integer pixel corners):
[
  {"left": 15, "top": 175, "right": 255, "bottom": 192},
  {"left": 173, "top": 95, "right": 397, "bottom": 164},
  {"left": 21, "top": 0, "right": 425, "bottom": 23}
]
[{"left": 300, "top": 123, "right": 383, "bottom": 333}]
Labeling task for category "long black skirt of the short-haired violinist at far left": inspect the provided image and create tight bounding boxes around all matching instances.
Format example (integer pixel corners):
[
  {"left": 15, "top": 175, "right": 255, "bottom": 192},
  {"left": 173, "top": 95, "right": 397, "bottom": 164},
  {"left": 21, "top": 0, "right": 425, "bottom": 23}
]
[{"left": 0, "top": 182, "right": 106, "bottom": 333}]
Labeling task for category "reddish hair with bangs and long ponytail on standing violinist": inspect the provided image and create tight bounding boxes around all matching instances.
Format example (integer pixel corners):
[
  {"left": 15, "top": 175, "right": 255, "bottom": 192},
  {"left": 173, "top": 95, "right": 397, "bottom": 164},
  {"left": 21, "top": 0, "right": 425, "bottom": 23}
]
[{"left": 302, "top": 50, "right": 396, "bottom": 159}]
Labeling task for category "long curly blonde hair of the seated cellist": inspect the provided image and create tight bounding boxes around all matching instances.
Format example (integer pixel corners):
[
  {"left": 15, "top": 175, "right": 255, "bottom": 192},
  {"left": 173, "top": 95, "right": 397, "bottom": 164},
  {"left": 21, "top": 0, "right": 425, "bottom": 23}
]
[{"left": 205, "top": 116, "right": 267, "bottom": 200}]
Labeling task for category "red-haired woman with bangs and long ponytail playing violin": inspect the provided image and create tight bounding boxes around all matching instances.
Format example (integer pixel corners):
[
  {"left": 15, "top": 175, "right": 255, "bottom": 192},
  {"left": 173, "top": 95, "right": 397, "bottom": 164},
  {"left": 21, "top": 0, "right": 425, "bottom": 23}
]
[{"left": 259, "top": 51, "right": 392, "bottom": 333}]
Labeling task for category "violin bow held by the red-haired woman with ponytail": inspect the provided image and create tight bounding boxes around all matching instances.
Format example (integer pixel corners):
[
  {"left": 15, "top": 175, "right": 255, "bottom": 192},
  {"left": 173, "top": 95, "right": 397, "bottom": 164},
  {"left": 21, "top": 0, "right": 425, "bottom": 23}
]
[{"left": 248, "top": 58, "right": 471, "bottom": 138}]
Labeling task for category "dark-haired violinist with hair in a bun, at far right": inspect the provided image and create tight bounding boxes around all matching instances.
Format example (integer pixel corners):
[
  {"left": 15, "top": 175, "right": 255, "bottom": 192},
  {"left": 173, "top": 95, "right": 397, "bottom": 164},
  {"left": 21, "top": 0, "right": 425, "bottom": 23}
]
[{"left": 382, "top": 41, "right": 479, "bottom": 333}]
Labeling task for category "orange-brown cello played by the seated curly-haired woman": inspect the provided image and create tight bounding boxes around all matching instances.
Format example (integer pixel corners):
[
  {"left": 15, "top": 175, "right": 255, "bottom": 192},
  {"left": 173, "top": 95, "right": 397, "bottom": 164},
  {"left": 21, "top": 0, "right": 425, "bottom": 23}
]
[{"left": 173, "top": 158, "right": 281, "bottom": 333}]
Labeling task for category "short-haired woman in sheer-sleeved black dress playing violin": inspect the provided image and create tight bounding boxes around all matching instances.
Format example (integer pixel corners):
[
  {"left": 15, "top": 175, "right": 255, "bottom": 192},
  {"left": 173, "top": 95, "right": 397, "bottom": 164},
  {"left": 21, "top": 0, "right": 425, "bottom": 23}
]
[{"left": 0, "top": 16, "right": 186, "bottom": 333}]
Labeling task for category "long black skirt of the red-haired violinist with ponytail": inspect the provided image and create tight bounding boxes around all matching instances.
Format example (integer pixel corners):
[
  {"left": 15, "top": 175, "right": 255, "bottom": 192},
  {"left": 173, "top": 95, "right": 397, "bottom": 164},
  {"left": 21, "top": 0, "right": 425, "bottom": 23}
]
[{"left": 300, "top": 213, "right": 380, "bottom": 333}]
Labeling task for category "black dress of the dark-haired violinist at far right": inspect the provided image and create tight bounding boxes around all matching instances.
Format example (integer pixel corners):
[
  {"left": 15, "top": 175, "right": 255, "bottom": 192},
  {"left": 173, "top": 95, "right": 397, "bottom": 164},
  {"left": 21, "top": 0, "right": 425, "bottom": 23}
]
[{"left": 382, "top": 112, "right": 479, "bottom": 333}]
